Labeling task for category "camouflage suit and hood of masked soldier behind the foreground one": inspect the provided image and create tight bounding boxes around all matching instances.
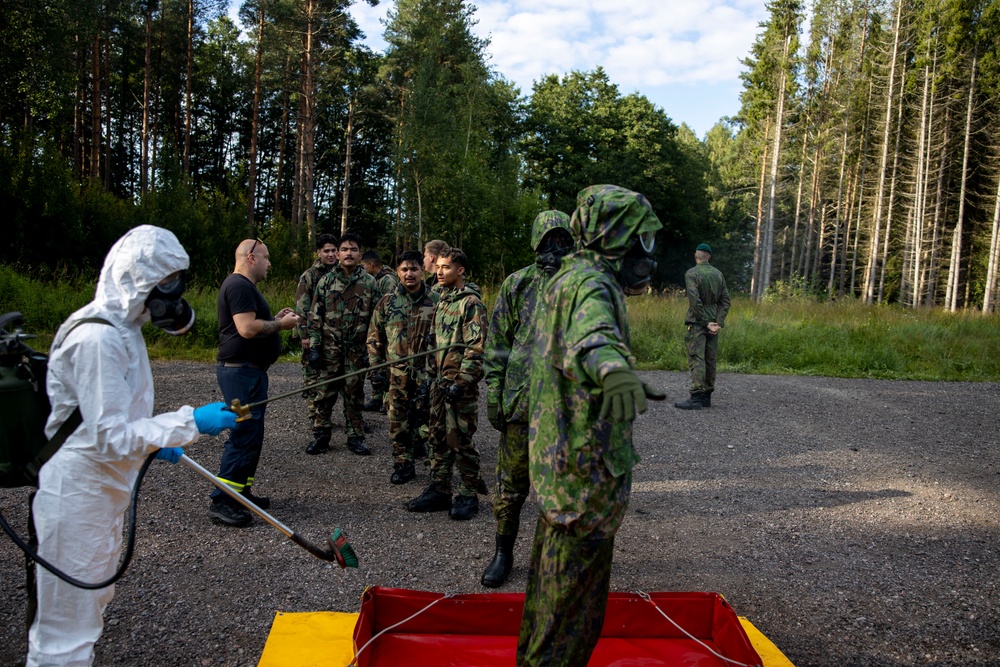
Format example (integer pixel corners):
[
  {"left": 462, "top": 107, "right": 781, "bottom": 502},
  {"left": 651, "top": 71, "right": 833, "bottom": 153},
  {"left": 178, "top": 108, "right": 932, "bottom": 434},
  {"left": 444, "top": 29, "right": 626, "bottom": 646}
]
[{"left": 483, "top": 211, "right": 569, "bottom": 535}]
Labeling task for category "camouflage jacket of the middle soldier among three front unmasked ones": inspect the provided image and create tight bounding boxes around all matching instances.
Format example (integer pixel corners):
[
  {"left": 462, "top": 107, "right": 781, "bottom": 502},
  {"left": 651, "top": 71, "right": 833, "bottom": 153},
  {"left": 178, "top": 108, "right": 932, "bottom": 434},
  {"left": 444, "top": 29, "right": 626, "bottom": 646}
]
[{"left": 367, "top": 284, "right": 440, "bottom": 382}]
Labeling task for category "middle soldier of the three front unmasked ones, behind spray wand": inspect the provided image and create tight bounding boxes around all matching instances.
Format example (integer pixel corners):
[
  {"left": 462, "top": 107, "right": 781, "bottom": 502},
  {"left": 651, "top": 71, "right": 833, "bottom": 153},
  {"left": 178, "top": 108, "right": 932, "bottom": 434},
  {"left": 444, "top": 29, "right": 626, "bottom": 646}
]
[{"left": 368, "top": 250, "right": 439, "bottom": 484}]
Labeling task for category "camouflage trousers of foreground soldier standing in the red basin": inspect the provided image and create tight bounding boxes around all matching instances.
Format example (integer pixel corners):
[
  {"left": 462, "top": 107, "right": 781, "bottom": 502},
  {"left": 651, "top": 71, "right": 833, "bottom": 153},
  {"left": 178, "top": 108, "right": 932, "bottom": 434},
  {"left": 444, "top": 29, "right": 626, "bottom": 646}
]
[{"left": 517, "top": 516, "right": 615, "bottom": 667}]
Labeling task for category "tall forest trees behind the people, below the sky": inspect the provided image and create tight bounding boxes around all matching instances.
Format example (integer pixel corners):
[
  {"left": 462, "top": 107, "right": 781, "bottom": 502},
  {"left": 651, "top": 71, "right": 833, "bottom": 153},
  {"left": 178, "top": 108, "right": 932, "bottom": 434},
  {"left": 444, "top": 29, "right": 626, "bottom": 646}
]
[{"left": 0, "top": 0, "right": 1000, "bottom": 311}]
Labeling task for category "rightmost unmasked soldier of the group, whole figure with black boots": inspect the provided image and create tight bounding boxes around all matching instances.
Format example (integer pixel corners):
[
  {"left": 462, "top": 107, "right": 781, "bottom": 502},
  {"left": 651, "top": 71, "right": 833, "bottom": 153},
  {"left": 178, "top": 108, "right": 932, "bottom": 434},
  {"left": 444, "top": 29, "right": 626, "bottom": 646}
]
[{"left": 407, "top": 248, "right": 486, "bottom": 520}]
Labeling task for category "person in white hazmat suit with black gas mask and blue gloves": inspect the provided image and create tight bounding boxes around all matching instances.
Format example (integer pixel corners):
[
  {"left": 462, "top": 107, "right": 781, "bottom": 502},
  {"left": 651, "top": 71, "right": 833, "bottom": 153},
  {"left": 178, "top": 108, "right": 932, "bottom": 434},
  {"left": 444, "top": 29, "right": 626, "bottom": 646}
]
[{"left": 27, "top": 225, "right": 236, "bottom": 667}]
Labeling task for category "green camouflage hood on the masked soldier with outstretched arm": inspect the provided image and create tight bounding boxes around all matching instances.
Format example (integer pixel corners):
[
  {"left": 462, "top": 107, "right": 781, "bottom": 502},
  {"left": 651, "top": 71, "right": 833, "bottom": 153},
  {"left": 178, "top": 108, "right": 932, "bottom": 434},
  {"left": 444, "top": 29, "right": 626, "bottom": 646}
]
[{"left": 570, "top": 185, "right": 663, "bottom": 260}]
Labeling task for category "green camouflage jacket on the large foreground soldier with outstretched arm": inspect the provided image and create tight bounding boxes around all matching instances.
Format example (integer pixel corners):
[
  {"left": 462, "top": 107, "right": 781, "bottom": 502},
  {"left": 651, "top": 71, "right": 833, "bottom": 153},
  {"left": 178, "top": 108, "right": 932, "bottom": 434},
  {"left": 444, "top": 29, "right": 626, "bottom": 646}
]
[{"left": 528, "top": 249, "right": 639, "bottom": 539}]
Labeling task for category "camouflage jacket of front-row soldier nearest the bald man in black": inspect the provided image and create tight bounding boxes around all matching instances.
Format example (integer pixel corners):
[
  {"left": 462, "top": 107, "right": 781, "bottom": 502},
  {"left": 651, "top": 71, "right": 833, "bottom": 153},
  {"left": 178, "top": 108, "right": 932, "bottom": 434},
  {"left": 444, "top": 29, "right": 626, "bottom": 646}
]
[{"left": 309, "top": 266, "right": 375, "bottom": 371}]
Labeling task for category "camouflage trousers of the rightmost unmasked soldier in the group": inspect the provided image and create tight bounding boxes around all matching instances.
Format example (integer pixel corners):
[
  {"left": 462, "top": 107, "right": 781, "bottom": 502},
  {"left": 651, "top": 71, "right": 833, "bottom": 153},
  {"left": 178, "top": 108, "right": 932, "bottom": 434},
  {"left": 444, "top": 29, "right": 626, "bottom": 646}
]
[{"left": 428, "top": 385, "right": 487, "bottom": 496}]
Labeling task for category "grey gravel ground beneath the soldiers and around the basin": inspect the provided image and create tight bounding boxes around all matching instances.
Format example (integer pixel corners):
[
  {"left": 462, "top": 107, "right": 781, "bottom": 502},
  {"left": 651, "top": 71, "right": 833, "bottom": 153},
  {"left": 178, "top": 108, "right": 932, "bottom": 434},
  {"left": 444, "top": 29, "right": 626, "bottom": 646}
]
[{"left": 0, "top": 362, "right": 1000, "bottom": 667}]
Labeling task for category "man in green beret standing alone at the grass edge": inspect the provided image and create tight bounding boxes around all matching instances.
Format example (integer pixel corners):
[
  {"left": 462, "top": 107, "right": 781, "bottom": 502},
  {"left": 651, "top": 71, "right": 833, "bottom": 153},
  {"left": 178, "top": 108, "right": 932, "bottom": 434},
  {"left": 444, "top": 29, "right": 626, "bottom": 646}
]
[{"left": 674, "top": 243, "right": 729, "bottom": 410}]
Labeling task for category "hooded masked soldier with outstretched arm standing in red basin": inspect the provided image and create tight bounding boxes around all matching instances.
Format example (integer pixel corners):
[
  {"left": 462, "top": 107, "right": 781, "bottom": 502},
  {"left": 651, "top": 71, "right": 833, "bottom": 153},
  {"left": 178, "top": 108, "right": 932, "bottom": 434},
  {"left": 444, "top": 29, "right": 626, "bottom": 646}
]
[{"left": 517, "top": 185, "right": 662, "bottom": 667}]
